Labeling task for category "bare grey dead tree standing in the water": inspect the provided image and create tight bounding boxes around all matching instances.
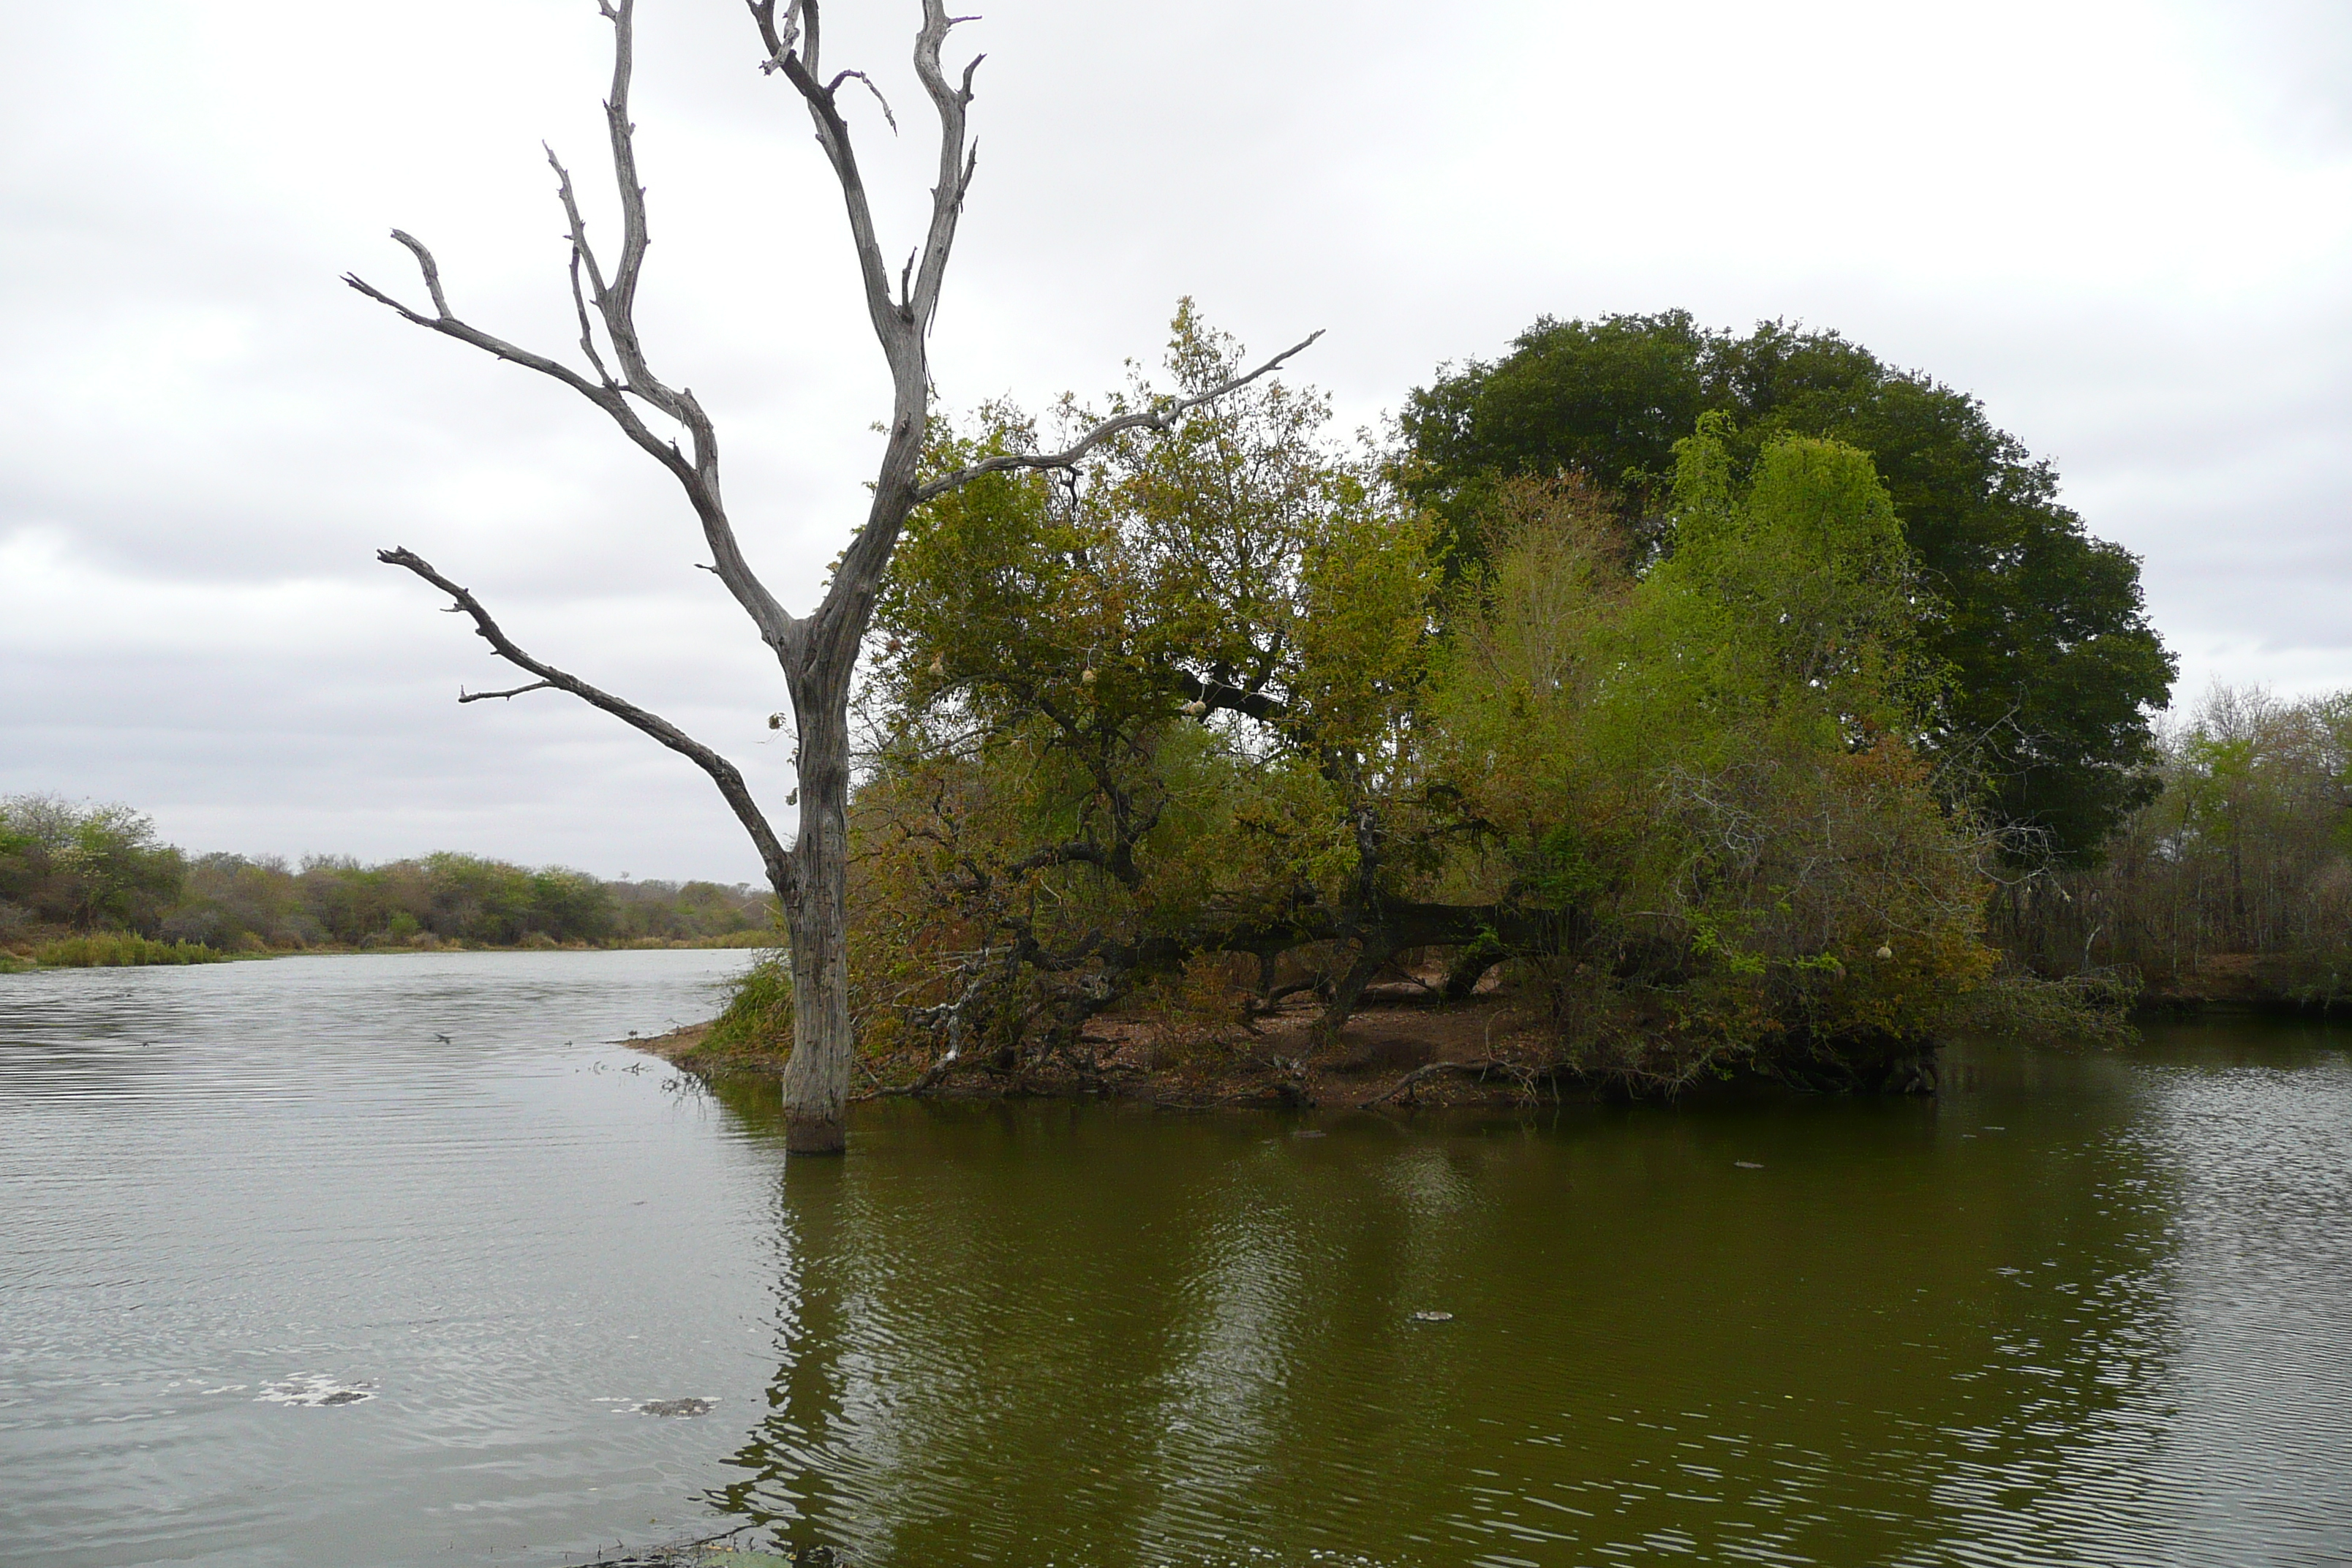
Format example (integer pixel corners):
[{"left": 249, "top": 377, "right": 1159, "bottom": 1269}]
[{"left": 344, "top": 0, "right": 1322, "bottom": 1154}]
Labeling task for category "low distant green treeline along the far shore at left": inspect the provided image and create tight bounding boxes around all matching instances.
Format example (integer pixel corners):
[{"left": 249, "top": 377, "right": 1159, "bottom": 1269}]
[{"left": 0, "top": 794, "right": 772, "bottom": 954}]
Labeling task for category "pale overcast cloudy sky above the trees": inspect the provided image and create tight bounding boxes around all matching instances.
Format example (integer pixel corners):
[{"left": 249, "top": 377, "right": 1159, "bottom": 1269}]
[{"left": 0, "top": 0, "right": 2352, "bottom": 881}]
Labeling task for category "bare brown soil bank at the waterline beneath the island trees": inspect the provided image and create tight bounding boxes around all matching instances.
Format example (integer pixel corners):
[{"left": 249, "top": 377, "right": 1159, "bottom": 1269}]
[{"left": 621, "top": 983, "right": 1550, "bottom": 1109}]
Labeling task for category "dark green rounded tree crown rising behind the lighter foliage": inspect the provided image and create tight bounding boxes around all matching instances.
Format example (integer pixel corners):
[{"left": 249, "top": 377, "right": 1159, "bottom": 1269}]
[{"left": 1402, "top": 310, "right": 2176, "bottom": 858}]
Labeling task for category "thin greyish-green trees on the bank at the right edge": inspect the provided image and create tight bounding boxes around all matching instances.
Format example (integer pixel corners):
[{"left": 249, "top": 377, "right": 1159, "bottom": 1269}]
[{"left": 1992, "top": 687, "right": 2352, "bottom": 1004}]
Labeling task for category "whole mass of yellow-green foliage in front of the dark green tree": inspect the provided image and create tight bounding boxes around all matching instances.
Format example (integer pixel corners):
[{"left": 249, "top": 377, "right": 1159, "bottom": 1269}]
[{"left": 853, "top": 310, "right": 2022, "bottom": 1086}]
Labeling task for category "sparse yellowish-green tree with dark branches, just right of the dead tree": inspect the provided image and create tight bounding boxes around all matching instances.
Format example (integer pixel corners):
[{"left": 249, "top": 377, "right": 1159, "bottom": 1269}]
[{"left": 851, "top": 306, "right": 1435, "bottom": 1067}]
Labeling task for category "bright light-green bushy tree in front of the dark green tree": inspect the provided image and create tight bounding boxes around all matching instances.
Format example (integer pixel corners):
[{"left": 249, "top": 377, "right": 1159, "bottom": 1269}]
[{"left": 1428, "top": 421, "right": 1992, "bottom": 1084}]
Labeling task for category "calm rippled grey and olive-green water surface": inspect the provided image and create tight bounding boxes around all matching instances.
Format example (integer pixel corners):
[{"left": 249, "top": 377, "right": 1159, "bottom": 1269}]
[{"left": 0, "top": 952, "right": 2352, "bottom": 1568}]
